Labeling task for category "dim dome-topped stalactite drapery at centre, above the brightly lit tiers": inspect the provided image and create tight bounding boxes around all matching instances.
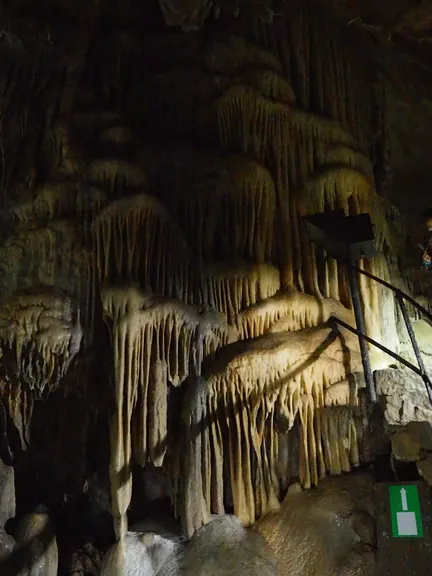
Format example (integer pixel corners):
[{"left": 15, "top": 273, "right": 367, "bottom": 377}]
[{"left": 157, "top": 149, "right": 275, "bottom": 263}]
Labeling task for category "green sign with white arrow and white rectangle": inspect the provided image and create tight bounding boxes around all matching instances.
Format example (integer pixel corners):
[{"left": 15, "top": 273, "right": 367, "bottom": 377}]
[{"left": 389, "top": 484, "right": 423, "bottom": 538}]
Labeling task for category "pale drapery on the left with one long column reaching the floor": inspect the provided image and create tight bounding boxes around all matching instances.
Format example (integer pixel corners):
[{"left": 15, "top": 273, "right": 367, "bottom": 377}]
[{"left": 102, "top": 287, "right": 233, "bottom": 536}]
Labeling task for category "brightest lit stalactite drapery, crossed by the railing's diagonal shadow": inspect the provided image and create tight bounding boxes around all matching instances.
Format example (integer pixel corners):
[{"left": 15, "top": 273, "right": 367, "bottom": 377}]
[{"left": 179, "top": 327, "right": 360, "bottom": 535}]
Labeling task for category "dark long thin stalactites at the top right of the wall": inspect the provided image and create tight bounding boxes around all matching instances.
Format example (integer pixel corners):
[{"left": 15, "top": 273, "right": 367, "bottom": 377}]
[{"left": 244, "top": 0, "right": 375, "bottom": 146}]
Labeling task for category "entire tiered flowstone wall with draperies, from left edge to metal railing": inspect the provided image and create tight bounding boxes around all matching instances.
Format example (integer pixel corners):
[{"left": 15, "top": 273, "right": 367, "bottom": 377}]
[{"left": 0, "top": 2, "right": 416, "bottom": 564}]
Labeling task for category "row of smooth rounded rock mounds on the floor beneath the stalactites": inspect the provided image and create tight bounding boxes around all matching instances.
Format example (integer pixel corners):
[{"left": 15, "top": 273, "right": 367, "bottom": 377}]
[{"left": 102, "top": 474, "right": 376, "bottom": 576}]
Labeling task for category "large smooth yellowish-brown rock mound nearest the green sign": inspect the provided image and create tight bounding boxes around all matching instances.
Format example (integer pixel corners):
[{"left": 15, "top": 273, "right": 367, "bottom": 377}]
[{"left": 254, "top": 474, "right": 375, "bottom": 576}]
